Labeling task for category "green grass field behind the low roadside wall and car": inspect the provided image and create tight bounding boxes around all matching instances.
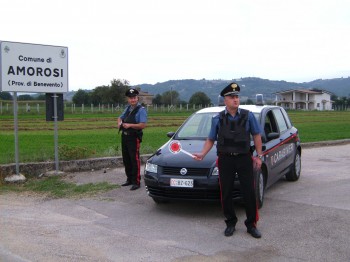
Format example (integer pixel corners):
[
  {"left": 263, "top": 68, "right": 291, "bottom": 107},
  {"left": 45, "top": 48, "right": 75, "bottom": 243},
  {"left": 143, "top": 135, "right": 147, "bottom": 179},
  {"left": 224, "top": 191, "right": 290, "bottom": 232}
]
[{"left": 0, "top": 108, "right": 350, "bottom": 164}]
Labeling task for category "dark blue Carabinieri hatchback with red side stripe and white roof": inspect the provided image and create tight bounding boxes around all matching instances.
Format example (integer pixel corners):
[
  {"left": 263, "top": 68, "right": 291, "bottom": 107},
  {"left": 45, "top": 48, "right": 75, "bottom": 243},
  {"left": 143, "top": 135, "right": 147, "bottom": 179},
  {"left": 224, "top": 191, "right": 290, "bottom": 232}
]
[{"left": 144, "top": 101, "right": 301, "bottom": 208}]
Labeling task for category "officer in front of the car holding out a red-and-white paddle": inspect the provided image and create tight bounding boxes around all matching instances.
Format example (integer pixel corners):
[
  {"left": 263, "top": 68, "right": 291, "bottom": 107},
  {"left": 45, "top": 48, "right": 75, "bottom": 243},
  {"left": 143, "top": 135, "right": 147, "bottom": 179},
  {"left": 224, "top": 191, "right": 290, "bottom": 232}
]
[{"left": 194, "top": 83, "right": 262, "bottom": 238}]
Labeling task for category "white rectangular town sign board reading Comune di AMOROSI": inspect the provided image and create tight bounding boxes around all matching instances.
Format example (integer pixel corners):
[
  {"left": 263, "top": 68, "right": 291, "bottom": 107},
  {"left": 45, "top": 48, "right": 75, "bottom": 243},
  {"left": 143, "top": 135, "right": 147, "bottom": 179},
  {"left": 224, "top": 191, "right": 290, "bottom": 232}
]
[{"left": 0, "top": 41, "right": 68, "bottom": 93}]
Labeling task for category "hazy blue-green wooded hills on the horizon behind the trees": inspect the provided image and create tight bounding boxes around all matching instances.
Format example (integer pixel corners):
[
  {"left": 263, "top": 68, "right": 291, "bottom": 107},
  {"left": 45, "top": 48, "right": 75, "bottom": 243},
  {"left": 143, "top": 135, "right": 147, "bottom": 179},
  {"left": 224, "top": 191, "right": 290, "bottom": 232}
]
[{"left": 136, "top": 77, "right": 350, "bottom": 104}]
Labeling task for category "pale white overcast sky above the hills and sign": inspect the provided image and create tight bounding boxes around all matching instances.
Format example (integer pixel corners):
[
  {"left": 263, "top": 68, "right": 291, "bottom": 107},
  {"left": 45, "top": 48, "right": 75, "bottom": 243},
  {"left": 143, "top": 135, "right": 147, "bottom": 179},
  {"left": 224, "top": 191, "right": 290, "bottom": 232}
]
[{"left": 0, "top": 0, "right": 350, "bottom": 90}]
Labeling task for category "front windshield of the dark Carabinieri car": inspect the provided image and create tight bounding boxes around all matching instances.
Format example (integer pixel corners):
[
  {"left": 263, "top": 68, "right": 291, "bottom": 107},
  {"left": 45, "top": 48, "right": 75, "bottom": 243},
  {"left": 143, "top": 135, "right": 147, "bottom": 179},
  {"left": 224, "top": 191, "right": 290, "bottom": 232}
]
[{"left": 176, "top": 112, "right": 259, "bottom": 140}]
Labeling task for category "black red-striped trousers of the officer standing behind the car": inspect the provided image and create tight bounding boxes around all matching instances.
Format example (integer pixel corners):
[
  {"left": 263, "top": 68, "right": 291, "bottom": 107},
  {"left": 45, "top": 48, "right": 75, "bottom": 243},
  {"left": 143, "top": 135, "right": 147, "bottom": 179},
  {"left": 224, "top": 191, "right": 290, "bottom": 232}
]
[{"left": 122, "top": 134, "right": 141, "bottom": 186}]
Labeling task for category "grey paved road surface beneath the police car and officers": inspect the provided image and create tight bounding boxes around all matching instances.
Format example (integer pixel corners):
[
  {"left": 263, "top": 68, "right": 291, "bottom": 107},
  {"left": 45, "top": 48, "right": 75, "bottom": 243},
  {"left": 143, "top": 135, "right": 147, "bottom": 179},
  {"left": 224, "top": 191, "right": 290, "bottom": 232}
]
[{"left": 0, "top": 145, "right": 350, "bottom": 262}]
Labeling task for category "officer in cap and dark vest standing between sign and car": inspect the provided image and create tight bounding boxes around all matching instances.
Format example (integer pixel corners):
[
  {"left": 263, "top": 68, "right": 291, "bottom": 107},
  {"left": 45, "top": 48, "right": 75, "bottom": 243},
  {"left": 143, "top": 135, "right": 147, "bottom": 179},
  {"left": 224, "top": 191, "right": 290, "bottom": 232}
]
[{"left": 118, "top": 88, "right": 147, "bottom": 190}]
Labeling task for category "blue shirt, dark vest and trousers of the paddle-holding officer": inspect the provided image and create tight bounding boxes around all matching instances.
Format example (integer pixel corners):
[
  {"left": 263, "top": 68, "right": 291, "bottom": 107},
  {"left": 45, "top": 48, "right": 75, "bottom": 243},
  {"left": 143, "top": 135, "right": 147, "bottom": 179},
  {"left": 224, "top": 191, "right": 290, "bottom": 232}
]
[{"left": 209, "top": 109, "right": 259, "bottom": 228}]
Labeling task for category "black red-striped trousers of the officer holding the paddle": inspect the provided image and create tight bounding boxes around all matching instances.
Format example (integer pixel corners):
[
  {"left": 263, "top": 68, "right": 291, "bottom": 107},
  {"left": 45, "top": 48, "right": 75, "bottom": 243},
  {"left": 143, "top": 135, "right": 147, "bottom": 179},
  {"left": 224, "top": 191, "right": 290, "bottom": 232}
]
[{"left": 218, "top": 154, "right": 259, "bottom": 229}]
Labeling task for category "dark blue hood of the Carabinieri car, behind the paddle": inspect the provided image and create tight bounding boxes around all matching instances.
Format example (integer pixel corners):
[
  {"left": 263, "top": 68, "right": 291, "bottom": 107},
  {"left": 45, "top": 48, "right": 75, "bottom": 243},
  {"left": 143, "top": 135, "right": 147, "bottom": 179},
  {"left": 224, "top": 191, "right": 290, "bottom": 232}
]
[{"left": 149, "top": 139, "right": 217, "bottom": 168}]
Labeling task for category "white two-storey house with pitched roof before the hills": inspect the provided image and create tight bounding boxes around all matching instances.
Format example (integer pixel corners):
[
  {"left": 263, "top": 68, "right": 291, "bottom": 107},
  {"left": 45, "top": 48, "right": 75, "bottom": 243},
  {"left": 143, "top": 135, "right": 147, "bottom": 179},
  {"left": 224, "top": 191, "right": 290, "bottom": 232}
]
[{"left": 275, "top": 89, "right": 332, "bottom": 111}]
